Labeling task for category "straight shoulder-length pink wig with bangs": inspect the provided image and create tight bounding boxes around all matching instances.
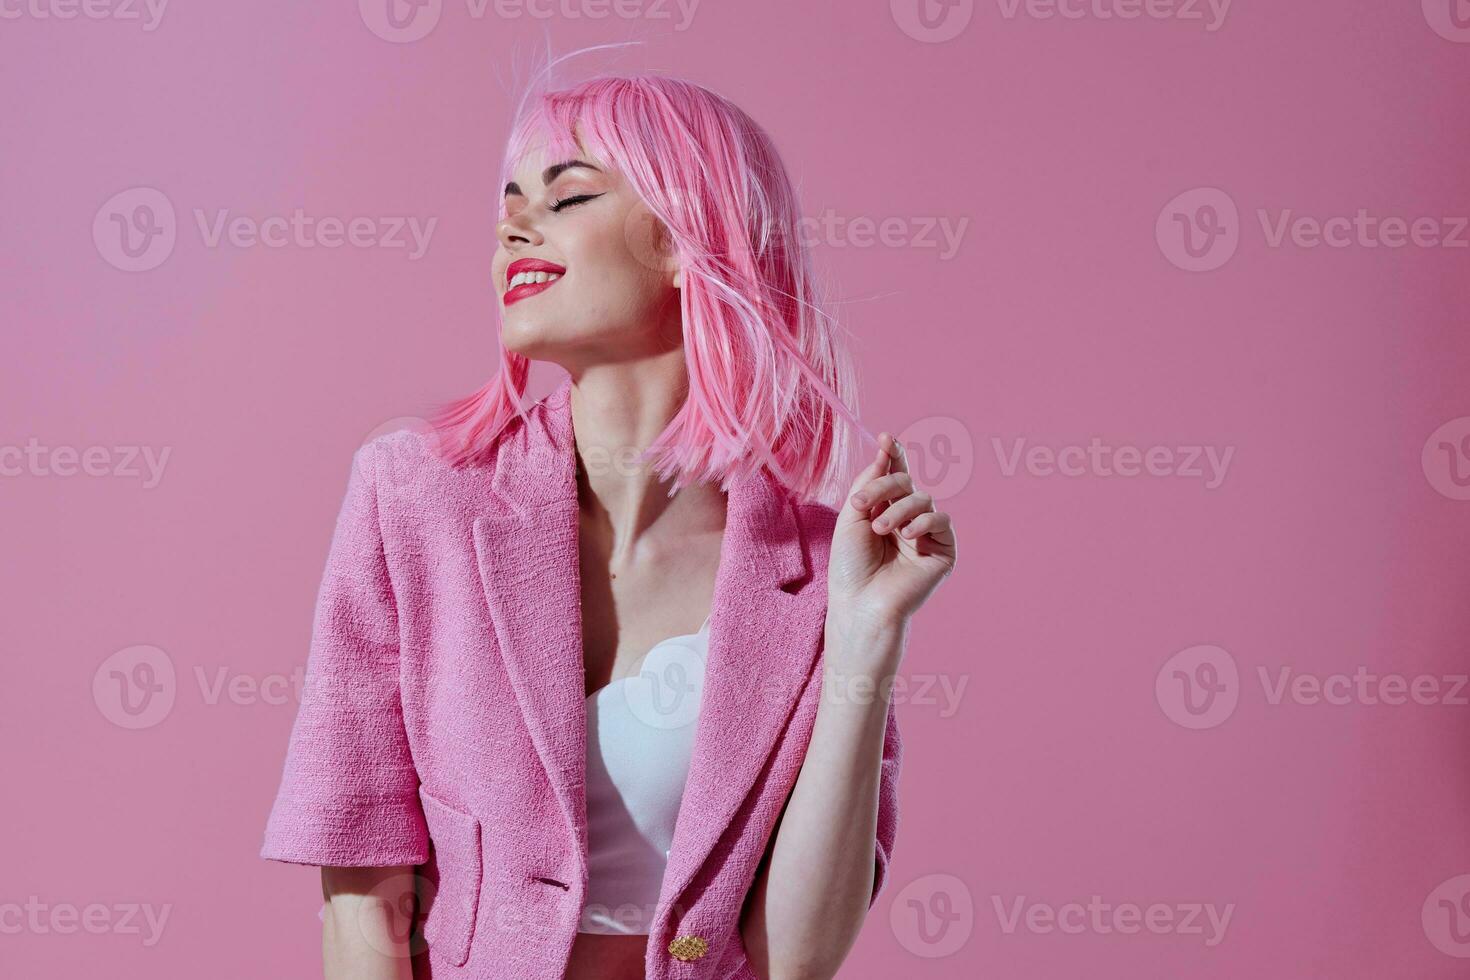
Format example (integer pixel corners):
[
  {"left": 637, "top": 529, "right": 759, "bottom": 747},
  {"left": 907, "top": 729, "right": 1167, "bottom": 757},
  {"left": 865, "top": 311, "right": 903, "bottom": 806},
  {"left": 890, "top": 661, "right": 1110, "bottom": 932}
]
[{"left": 432, "top": 63, "right": 872, "bottom": 505}]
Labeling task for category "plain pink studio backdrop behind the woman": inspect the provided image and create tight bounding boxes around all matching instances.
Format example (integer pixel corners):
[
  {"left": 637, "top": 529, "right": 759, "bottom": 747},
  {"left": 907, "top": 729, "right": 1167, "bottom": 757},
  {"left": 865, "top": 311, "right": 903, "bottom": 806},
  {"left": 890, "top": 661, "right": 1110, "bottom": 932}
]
[{"left": 0, "top": 0, "right": 1470, "bottom": 980}]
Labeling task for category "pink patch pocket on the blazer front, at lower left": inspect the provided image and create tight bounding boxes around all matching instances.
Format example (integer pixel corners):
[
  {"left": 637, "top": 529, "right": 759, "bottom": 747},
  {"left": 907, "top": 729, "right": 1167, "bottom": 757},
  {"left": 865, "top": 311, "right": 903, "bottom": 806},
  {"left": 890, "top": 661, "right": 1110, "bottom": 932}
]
[{"left": 419, "top": 786, "right": 482, "bottom": 967}]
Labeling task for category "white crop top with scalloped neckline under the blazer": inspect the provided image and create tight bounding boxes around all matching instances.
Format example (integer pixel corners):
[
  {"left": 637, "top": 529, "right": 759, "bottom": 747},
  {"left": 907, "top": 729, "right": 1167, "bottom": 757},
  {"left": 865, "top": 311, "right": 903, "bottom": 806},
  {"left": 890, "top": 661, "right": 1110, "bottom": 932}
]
[{"left": 578, "top": 619, "right": 710, "bottom": 936}]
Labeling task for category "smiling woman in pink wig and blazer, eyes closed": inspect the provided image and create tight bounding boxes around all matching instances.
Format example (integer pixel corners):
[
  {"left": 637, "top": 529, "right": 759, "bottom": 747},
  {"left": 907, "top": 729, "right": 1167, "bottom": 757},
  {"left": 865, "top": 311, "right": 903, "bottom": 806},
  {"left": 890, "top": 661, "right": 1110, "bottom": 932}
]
[{"left": 262, "top": 70, "right": 956, "bottom": 980}]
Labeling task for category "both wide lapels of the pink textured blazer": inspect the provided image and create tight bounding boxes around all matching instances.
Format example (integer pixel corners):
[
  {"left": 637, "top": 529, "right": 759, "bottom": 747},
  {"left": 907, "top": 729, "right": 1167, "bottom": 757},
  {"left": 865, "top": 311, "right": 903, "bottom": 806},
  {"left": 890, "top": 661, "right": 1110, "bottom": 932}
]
[{"left": 473, "top": 381, "right": 826, "bottom": 907}]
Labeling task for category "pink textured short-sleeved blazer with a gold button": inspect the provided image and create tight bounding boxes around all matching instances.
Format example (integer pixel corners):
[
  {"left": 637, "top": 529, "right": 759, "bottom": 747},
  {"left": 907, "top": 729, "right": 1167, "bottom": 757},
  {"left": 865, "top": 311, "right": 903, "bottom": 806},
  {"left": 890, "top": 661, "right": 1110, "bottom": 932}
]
[{"left": 262, "top": 381, "right": 901, "bottom": 980}]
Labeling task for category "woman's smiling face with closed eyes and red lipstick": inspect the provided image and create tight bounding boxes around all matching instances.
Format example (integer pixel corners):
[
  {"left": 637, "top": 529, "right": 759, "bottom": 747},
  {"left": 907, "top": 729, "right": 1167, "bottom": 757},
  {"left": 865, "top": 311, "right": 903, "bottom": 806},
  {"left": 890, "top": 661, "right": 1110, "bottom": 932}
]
[{"left": 491, "top": 135, "right": 682, "bottom": 370}]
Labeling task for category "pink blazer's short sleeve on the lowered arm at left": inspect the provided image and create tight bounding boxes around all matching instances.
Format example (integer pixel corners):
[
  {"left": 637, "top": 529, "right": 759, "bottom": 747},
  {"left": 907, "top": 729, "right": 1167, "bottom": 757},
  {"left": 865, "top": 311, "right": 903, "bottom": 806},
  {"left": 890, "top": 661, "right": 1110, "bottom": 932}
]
[{"left": 260, "top": 442, "right": 428, "bottom": 867}]
